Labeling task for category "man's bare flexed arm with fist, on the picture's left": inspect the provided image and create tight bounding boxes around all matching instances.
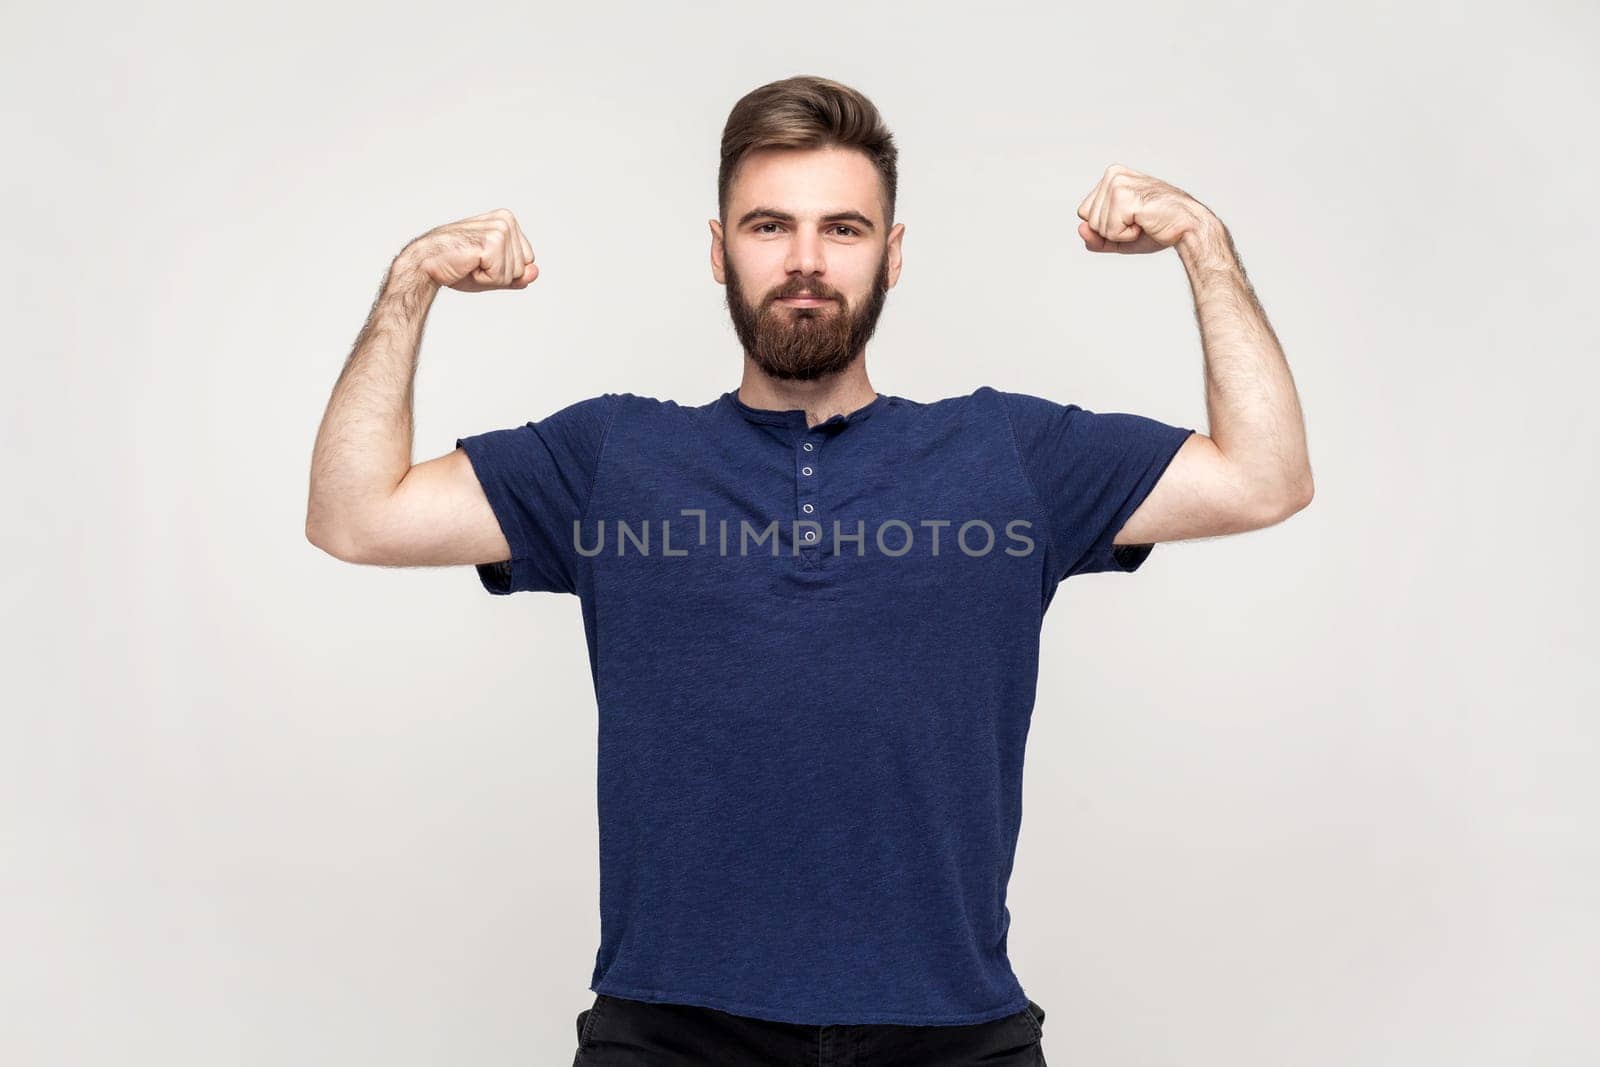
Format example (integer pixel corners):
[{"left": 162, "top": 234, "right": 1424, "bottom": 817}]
[{"left": 306, "top": 210, "right": 538, "bottom": 566}]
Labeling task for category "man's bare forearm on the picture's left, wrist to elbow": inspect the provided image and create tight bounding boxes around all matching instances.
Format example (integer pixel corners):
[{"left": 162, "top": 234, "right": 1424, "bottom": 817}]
[{"left": 306, "top": 253, "right": 438, "bottom": 550}]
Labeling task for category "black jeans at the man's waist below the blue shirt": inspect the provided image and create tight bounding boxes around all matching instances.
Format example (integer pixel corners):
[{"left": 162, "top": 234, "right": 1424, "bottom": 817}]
[{"left": 573, "top": 993, "right": 1046, "bottom": 1067}]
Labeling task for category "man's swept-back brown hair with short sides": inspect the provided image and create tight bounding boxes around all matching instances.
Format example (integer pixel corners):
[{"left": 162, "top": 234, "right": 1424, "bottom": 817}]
[{"left": 717, "top": 74, "right": 899, "bottom": 227}]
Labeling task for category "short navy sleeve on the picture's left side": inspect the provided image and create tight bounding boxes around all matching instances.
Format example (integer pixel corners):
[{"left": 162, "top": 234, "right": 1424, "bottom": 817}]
[{"left": 456, "top": 394, "right": 618, "bottom": 595}]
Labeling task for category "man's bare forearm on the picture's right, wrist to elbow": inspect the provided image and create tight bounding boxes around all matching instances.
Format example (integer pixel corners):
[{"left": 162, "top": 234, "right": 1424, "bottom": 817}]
[{"left": 1178, "top": 216, "right": 1312, "bottom": 510}]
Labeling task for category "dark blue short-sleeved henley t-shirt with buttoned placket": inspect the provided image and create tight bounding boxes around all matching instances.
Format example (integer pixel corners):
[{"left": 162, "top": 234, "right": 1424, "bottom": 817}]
[{"left": 456, "top": 387, "right": 1192, "bottom": 1025}]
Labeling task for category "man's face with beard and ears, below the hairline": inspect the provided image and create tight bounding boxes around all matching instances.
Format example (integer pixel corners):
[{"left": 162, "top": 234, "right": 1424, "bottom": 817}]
[{"left": 710, "top": 149, "right": 906, "bottom": 381}]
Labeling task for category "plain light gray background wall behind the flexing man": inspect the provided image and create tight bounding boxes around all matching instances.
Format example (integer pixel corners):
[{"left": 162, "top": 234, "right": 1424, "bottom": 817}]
[{"left": 0, "top": 2, "right": 1600, "bottom": 1067}]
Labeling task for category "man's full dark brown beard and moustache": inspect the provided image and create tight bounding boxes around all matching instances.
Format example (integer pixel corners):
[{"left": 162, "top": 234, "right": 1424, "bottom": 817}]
[{"left": 723, "top": 248, "right": 890, "bottom": 381}]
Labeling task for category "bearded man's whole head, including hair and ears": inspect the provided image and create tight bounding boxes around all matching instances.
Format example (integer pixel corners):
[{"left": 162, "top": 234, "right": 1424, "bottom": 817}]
[{"left": 710, "top": 77, "right": 906, "bottom": 381}]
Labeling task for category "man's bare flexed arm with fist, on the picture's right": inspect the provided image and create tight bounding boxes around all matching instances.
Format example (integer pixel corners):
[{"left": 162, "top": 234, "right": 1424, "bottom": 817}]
[{"left": 1078, "top": 165, "right": 1312, "bottom": 544}]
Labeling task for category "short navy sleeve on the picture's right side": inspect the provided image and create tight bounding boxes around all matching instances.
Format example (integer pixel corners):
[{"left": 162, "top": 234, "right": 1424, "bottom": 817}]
[{"left": 1000, "top": 392, "right": 1194, "bottom": 581}]
